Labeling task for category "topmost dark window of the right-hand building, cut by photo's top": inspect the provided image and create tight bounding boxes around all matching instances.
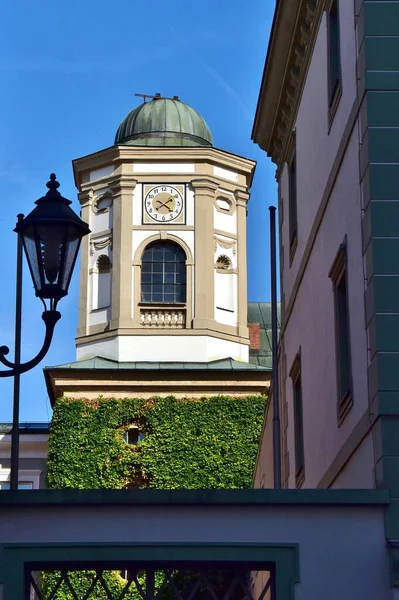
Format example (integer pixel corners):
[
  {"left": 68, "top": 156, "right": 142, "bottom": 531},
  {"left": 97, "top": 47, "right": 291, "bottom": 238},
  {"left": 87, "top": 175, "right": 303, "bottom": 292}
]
[{"left": 326, "top": 0, "right": 342, "bottom": 126}]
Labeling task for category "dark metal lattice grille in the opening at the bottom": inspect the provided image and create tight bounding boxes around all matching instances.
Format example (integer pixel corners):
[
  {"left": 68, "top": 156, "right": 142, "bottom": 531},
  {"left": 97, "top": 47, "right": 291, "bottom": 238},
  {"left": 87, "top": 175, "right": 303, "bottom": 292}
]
[{"left": 26, "top": 563, "right": 275, "bottom": 600}]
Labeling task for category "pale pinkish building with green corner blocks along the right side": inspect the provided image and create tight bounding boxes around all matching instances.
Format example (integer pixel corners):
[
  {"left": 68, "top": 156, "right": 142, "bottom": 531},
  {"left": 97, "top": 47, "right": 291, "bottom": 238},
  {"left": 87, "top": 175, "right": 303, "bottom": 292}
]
[{"left": 253, "top": 0, "right": 399, "bottom": 520}]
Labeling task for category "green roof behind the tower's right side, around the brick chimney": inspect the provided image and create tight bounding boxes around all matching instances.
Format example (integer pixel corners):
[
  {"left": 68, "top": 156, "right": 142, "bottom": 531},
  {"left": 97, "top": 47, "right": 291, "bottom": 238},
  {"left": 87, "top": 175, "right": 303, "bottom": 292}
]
[{"left": 248, "top": 302, "right": 280, "bottom": 371}]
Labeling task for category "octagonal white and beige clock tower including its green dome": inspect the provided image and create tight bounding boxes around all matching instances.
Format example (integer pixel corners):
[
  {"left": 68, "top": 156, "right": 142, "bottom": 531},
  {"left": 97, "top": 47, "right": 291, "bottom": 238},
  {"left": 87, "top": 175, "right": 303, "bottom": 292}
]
[{"left": 73, "top": 95, "right": 255, "bottom": 363}]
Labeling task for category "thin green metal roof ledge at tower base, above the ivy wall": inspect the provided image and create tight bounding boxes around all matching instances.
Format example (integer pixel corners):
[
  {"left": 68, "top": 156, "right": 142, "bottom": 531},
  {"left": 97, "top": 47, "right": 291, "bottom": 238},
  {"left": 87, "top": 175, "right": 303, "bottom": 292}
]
[{"left": 44, "top": 356, "right": 267, "bottom": 371}]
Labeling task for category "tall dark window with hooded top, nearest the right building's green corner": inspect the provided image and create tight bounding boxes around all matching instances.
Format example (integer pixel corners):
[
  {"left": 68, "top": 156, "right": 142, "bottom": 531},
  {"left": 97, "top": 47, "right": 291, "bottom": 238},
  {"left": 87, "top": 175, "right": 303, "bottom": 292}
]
[{"left": 330, "top": 243, "right": 353, "bottom": 424}]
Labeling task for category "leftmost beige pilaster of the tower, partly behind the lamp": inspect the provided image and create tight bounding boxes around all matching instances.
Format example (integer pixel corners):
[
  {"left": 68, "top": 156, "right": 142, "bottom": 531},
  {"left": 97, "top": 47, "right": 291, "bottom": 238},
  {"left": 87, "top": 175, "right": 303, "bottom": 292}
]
[{"left": 76, "top": 189, "right": 93, "bottom": 338}]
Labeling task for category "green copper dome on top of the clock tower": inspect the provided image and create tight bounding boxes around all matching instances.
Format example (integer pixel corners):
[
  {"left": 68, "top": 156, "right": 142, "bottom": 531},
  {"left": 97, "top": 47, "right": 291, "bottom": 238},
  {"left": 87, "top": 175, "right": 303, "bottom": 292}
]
[{"left": 115, "top": 97, "right": 213, "bottom": 146}]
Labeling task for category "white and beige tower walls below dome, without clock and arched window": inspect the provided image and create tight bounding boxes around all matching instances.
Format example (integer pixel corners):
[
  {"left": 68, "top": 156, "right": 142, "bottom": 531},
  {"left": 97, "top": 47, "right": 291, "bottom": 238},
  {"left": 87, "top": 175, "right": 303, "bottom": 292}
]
[{"left": 74, "top": 146, "right": 255, "bottom": 362}]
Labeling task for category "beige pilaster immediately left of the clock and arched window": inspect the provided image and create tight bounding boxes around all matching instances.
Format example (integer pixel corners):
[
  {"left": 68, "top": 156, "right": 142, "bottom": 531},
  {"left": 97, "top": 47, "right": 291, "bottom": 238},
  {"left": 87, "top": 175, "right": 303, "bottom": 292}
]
[{"left": 109, "top": 175, "right": 137, "bottom": 330}]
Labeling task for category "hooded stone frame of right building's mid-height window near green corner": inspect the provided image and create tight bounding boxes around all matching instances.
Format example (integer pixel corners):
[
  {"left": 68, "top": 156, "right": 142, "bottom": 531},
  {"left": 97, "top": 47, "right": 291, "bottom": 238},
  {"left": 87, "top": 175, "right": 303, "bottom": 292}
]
[{"left": 329, "top": 236, "right": 353, "bottom": 427}]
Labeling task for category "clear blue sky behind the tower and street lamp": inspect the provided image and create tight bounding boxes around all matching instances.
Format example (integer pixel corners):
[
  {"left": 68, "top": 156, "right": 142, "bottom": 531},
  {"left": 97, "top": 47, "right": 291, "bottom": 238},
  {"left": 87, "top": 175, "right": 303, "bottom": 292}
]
[{"left": 0, "top": 0, "right": 276, "bottom": 421}]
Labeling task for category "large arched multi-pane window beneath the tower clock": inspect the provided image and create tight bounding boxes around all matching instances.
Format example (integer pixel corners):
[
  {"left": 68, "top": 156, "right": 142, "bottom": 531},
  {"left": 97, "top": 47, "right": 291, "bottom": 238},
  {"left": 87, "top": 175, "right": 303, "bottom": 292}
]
[{"left": 139, "top": 239, "right": 187, "bottom": 307}]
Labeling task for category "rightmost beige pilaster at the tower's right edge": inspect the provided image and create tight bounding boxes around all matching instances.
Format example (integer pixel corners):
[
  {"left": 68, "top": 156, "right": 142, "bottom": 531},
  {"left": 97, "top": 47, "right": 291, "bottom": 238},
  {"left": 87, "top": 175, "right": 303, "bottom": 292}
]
[{"left": 235, "top": 190, "right": 249, "bottom": 338}]
